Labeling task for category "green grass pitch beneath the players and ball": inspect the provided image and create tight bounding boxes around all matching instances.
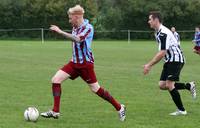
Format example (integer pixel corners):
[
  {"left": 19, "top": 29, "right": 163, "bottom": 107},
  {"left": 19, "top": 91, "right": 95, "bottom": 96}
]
[{"left": 0, "top": 41, "right": 200, "bottom": 128}]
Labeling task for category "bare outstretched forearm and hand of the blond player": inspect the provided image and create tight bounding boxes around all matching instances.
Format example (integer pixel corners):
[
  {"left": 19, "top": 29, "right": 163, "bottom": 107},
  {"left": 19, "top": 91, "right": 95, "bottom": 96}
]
[{"left": 49, "top": 25, "right": 81, "bottom": 42}]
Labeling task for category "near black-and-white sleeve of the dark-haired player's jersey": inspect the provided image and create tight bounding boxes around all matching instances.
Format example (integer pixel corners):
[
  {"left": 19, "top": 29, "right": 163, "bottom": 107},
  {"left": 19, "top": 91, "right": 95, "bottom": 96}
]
[{"left": 159, "top": 33, "right": 169, "bottom": 50}]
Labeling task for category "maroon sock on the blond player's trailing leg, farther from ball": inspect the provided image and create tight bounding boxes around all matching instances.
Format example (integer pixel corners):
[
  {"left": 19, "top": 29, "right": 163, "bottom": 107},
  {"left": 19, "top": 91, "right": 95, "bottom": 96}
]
[{"left": 96, "top": 87, "right": 121, "bottom": 111}]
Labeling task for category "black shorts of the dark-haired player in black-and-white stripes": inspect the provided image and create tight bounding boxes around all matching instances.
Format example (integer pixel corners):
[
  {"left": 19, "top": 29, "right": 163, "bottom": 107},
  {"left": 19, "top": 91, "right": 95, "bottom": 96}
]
[{"left": 160, "top": 62, "right": 184, "bottom": 81}]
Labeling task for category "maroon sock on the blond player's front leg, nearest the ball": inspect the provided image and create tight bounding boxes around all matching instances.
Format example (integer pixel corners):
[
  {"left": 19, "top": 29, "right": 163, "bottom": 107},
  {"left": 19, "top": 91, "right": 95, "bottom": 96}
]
[{"left": 52, "top": 83, "right": 61, "bottom": 112}]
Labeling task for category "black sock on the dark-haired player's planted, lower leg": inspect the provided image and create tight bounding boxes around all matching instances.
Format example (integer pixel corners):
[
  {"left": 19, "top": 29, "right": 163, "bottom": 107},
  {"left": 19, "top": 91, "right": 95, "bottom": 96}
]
[{"left": 170, "top": 88, "right": 185, "bottom": 111}]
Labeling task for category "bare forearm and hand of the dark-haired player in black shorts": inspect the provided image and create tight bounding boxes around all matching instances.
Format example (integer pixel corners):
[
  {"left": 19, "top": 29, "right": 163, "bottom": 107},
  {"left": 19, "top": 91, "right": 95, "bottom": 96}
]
[{"left": 143, "top": 50, "right": 166, "bottom": 75}]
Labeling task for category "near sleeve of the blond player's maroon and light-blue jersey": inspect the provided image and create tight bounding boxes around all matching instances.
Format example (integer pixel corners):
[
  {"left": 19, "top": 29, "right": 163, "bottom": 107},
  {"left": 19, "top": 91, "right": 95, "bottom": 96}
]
[{"left": 78, "top": 27, "right": 93, "bottom": 42}]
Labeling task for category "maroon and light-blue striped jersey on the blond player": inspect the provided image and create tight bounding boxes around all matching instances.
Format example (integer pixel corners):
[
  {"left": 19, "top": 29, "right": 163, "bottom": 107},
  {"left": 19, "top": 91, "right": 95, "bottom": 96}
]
[{"left": 72, "top": 19, "right": 94, "bottom": 64}]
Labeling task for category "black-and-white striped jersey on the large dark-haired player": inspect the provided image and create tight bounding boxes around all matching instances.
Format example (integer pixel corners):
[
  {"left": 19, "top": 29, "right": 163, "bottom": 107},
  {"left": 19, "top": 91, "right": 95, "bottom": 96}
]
[{"left": 155, "top": 24, "right": 185, "bottom": 63}]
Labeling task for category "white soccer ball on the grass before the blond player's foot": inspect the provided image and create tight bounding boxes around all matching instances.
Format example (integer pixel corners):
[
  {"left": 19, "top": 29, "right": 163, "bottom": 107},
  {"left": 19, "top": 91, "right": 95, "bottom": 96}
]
[{"left": 24, "top": 107, "right": 39, "bottom": 122}]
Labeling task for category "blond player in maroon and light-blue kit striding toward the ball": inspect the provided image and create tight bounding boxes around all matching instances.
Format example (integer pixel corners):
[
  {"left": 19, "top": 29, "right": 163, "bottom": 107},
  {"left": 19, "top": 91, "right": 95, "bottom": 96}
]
[{"left": 41, "top": 5, "right": 126, "bottom": 121}]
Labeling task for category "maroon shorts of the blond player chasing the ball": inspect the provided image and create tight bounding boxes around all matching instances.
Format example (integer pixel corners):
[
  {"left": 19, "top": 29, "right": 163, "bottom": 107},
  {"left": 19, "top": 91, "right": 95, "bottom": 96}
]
[{"left": 61, "top": 61, "right": 97, "bottom": 84}]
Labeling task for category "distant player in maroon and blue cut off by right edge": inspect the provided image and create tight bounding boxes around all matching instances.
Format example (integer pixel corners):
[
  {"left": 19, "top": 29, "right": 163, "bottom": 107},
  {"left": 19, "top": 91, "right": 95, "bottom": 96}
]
[{"left": 192, "top": 27, "right": 200, "bottom": 55}]
